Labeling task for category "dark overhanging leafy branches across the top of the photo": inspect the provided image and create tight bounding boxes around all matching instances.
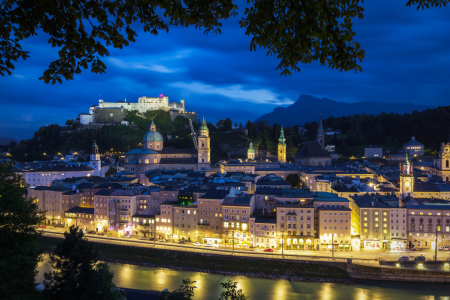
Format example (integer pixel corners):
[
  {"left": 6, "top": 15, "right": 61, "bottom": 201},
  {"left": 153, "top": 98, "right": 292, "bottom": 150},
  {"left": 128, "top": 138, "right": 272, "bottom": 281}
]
[{"left": 0, "top": 0, "right": 442, "bottom": 84}]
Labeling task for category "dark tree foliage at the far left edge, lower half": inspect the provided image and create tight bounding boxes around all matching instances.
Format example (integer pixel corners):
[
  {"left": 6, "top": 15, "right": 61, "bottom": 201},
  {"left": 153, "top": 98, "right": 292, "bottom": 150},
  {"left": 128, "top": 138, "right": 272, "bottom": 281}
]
[{"left": 0, "top": 163, "right": 45, "bottom": 300}]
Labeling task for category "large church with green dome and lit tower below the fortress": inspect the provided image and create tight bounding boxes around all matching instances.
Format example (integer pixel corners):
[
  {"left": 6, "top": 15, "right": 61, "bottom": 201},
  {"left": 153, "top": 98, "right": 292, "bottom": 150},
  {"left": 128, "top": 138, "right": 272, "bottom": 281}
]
[{"left": 124, "top": 118, "right": 211, "bottom": 175}]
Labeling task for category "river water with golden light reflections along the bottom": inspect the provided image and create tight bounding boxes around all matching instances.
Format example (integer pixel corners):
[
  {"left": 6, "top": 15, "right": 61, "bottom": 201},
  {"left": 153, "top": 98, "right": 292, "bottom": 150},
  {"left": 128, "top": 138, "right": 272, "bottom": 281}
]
[{"left": 36, "top": 260, "right": 450, "bottom": 300}]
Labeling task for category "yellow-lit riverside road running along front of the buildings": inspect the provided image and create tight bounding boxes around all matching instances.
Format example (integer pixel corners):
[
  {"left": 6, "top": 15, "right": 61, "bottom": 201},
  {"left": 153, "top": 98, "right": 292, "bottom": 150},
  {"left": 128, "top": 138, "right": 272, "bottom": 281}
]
[{"left": 40, "top": 227, "right": 450, "bottom": 265}]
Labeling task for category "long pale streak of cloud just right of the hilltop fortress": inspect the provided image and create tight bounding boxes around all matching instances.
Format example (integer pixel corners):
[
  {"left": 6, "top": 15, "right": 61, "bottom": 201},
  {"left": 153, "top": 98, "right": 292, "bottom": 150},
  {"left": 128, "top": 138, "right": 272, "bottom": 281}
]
[{"left": 169, "top": 82, "right": 293, "bottom": 105}]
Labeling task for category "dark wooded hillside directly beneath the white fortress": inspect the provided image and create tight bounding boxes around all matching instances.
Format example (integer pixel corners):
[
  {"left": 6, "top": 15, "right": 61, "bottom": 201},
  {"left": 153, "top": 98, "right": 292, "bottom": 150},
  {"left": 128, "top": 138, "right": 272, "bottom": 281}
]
[{"left": 9, "top": 111, "right": 194, "bottom": 161}]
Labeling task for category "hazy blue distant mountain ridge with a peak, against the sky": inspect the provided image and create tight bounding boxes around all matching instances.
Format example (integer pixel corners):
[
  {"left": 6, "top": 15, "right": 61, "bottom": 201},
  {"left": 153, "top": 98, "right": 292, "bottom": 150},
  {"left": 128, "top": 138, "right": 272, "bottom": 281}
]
[{"left": 255, "top": 94, "right": 435, "bottom": 127}]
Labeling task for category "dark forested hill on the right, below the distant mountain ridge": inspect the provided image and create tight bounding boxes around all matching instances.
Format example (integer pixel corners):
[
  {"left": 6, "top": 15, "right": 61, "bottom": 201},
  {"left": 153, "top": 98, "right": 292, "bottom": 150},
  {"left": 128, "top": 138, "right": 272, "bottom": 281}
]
[{"left": 304, "top": 106, "right": 450, "bottom": 155}]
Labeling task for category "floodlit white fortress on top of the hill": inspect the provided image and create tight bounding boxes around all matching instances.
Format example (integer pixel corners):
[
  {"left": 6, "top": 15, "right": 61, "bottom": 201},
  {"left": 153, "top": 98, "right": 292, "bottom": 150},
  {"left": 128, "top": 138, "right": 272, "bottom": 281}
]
[{"left": 77, "top": 94, "right": 197, "bottom": 128}]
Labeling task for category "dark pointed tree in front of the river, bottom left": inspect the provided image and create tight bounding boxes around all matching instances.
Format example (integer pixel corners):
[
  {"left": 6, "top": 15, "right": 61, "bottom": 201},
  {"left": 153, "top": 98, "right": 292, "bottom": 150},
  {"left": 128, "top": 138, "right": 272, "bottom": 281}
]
[{"left": 44, "top": 225, "right": 125, "bottom": 300}]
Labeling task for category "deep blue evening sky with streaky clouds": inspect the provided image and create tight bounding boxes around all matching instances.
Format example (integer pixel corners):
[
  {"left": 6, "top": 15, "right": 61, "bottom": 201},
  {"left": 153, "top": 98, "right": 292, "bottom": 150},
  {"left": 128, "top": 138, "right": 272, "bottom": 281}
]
[{"left": 0, "top": 0, "right": 450, "bottom": 139}]
